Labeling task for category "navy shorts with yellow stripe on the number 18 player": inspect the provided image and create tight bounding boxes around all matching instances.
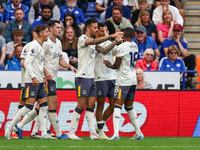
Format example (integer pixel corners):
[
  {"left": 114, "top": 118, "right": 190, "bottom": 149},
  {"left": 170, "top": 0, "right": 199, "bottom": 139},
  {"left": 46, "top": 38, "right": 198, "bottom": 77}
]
[{"left": 114, "top": 85, "right": 136, "bottom": 100}]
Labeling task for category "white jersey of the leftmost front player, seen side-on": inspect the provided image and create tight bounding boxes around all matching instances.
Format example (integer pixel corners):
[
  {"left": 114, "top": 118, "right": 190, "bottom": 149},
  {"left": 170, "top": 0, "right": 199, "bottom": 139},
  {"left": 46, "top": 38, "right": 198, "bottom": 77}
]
[{"left": 24, "top": 40, "right": 44, "bottom": 83}]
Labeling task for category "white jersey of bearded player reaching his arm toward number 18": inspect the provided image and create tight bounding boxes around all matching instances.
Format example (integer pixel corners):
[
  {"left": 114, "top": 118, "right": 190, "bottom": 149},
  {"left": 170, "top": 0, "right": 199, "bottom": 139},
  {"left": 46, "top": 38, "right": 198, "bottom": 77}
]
[{"left": 76, "top": 34, "right": 96, "bottom": 78}]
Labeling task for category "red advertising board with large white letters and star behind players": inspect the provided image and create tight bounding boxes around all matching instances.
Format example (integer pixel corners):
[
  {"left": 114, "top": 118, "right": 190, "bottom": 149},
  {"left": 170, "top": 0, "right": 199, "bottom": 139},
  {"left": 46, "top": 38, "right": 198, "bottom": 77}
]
[{"left": 0, "top": 89, "right": 200, "bottom": 137}]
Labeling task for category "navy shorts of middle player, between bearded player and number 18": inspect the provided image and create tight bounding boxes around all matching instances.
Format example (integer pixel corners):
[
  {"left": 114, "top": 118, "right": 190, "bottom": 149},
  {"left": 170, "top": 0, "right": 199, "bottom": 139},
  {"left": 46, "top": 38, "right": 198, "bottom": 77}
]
[{"left": 96, "top": 80, "right": 115, "bottom": 97}]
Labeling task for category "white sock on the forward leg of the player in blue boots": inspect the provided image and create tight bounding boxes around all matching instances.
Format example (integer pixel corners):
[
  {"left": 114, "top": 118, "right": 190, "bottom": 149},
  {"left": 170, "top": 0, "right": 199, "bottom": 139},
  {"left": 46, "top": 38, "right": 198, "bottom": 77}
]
[{"left": 48, "top": 112, "right": 62, "bottom": 137}]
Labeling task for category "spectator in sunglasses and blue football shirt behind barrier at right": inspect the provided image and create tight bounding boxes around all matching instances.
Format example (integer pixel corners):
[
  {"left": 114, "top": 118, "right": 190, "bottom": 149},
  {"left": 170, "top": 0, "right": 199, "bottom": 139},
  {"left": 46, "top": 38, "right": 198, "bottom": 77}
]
[{"left": 158, "top": 45, "right": 186, "bottom": 74}]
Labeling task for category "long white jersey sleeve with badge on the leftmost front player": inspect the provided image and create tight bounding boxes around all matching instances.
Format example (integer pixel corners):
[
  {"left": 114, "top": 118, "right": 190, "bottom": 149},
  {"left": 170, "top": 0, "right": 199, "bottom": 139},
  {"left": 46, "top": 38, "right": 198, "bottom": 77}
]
[{"left": 24, "top": 45, "right": 38, "bottom": 79}]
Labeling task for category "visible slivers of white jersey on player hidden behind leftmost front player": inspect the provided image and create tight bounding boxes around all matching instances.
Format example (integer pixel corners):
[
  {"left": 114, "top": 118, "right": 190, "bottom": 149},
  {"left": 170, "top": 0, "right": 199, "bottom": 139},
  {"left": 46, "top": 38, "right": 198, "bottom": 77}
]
[{"left": 20, "top": 43, "right": 30, "bottom": 87}]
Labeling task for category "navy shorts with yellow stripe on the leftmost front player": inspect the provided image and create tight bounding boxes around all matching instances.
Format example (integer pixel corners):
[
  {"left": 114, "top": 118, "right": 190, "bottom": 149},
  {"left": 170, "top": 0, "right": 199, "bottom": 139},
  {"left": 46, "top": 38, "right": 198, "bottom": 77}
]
[{"left": 25, "top": 83, "right": 47, "bottom": 99}]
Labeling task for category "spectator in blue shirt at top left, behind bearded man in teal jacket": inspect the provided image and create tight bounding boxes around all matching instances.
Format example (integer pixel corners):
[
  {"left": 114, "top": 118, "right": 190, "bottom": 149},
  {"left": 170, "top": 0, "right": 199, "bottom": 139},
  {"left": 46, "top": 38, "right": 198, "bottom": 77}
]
[{"left": 4, "top": 0, "right": 29, "bottom": 24}]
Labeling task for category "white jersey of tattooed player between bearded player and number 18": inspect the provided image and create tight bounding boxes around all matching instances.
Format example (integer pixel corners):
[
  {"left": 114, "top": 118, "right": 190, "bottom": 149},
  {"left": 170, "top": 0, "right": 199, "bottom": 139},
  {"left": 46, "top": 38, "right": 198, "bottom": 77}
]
[{"left": 94, "top": 40, "right": 117, "bottom": 81}]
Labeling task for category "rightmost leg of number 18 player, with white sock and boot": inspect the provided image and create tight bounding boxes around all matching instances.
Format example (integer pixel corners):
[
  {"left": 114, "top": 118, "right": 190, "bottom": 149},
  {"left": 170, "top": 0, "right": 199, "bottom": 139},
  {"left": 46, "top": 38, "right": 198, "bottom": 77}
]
[{"left": 124, "top": 100, "right": 144, "bottom": 140}]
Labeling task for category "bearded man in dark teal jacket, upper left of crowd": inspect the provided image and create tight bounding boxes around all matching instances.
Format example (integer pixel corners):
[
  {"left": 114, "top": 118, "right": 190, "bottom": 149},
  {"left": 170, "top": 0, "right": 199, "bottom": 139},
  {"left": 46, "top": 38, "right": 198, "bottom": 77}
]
[{"left": 3, "top": 8, "right": 31, "bottom": 43}]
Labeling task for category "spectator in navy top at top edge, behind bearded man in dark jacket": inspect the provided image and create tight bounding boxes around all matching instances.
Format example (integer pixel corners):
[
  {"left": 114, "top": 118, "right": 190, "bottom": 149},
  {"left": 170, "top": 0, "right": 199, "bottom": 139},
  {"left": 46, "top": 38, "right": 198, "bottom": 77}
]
[{"left": 105, "top": 0, "right": 131, "bottom": 22}]
